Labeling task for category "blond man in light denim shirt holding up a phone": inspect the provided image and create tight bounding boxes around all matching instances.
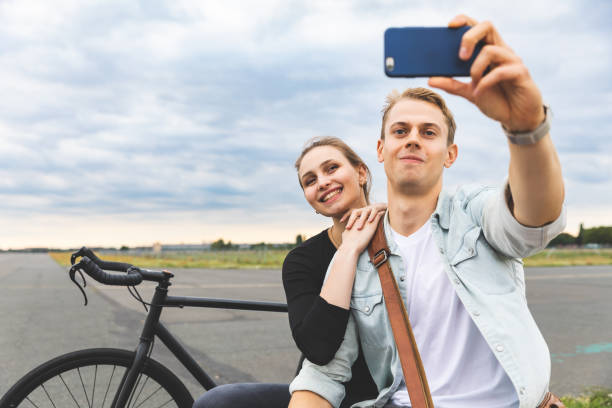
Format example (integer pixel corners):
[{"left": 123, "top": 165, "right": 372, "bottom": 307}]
[{"left": 290, "top": 15, "right": 565, "bottom": 408}]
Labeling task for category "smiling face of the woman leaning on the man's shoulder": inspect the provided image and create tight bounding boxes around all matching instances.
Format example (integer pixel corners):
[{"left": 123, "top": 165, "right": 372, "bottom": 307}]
[{"left": 298, "top": 146, "right": 367, "bottom": 217}]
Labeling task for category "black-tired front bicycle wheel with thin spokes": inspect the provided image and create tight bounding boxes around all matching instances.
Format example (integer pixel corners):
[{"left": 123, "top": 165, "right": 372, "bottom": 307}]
[{"left": 0, "top": 348, "right": 193, "bottom": 408}]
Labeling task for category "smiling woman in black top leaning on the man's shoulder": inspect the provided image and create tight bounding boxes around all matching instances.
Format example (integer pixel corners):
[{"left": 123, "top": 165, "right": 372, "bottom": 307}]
[{"left": 194, "top": 137, "right": 386, "bottom": 408}]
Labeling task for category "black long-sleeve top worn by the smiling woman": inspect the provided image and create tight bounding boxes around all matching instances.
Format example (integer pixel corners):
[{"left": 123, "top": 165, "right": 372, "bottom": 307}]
[{"left": 283, "top": 230, "right": 378, "bottom": 407}]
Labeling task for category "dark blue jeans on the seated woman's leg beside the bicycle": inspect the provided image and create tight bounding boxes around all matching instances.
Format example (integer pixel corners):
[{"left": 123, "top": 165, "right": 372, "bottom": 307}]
[{"left": 193, "top": 383, "right": 291, "bottom": 408}]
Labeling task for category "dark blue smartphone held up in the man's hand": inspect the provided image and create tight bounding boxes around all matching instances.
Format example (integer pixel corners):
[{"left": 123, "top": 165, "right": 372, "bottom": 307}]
[{"left": 385, "top": 26, "right": 483, "bottom": 77}]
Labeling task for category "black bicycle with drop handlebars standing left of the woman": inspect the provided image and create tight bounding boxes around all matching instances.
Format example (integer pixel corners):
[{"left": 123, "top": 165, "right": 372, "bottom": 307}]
[{"left": 0, "top": 247, "right": 287, "bottom": 408}]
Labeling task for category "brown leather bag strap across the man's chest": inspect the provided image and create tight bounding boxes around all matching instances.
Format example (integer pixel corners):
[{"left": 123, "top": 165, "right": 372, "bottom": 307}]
[{"left": 368, "top": 217, "right": 433, "bottom": 408}]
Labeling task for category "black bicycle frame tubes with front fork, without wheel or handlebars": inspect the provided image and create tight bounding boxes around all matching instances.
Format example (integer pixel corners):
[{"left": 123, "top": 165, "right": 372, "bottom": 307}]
[{"left": 111, "top": 278, "right": 287, "bottom": 408}]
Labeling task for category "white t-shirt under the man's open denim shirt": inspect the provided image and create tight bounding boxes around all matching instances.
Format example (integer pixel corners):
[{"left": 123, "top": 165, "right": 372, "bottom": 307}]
[{"left": 385, "top": 221, "right": 519, "bottom": 408}]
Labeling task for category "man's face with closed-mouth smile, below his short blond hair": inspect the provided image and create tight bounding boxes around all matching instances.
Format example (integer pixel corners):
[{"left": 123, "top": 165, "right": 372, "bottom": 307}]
[{"left": 377, "top": 98, "right": 457, "bottom": 193}]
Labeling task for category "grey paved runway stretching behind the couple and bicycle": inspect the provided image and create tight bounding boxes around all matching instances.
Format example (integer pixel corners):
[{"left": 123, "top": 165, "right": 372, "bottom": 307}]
[{"left": 0, "top": 253, "right": 612, "bottom": 396}]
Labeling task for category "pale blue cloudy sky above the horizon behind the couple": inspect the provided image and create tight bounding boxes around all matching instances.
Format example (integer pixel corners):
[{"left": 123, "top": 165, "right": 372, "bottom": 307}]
[{"left": 0, "top": 0, "right": 612, "bottom": 249}]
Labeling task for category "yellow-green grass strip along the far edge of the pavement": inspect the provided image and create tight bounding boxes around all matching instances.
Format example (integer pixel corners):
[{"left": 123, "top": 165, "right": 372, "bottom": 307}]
[{"left": 50, "top": 248, "right": 612, "bottom": 269}]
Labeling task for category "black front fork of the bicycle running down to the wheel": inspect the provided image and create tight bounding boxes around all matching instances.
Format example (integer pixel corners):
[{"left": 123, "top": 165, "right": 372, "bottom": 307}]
[{"left": 111, "top": 280, "right": 170, "bottom": 408}]
